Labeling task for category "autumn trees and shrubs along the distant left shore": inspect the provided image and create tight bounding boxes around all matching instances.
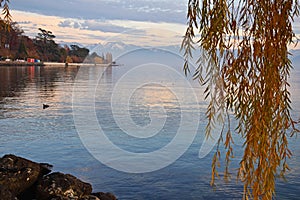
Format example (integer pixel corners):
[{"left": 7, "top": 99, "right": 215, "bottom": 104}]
[{"left": 0, "top": 20, "right": 94, "bottom": 63}]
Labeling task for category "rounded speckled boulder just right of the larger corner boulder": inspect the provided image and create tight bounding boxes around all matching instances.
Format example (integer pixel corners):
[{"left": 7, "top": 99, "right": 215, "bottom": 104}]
[{"left": 36, "top": 172, "right": 92, "bottom": 200}]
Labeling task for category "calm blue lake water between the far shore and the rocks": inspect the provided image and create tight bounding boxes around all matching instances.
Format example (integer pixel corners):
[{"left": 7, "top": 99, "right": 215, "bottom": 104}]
[{"left": 0, "top": 50, "right": 300, "bottom": 199}]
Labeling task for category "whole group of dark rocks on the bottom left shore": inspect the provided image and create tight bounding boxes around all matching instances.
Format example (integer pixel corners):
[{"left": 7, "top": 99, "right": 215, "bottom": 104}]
[{"left": 0, "top": 155, "right": 117, "bottom": 200}]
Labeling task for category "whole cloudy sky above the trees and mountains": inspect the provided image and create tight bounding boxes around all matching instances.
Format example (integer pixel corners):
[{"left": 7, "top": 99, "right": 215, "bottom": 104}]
[{"left": 10, "top": 0, "right": 300, "bottom": 49}]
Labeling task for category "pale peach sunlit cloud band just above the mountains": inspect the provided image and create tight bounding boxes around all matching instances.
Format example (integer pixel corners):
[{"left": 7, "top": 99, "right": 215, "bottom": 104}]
[{"left": 12, "top": 10, "right": 185, "bottom": 46}]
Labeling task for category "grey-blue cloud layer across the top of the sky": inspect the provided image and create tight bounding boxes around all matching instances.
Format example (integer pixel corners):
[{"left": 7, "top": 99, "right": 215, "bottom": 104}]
[{"left": 11, "top": 0, "right": 186, "bottom": 23}]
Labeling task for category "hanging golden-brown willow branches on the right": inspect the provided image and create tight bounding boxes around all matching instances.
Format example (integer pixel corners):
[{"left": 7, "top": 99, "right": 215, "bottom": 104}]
[{"left": 182, "top": 0, "right": 299, "bottom": 199}]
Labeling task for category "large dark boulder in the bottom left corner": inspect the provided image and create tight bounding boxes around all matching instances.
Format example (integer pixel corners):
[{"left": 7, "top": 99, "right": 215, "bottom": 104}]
[{"left": 0, "top": 155, "right": 51, "bottom": 200}]
